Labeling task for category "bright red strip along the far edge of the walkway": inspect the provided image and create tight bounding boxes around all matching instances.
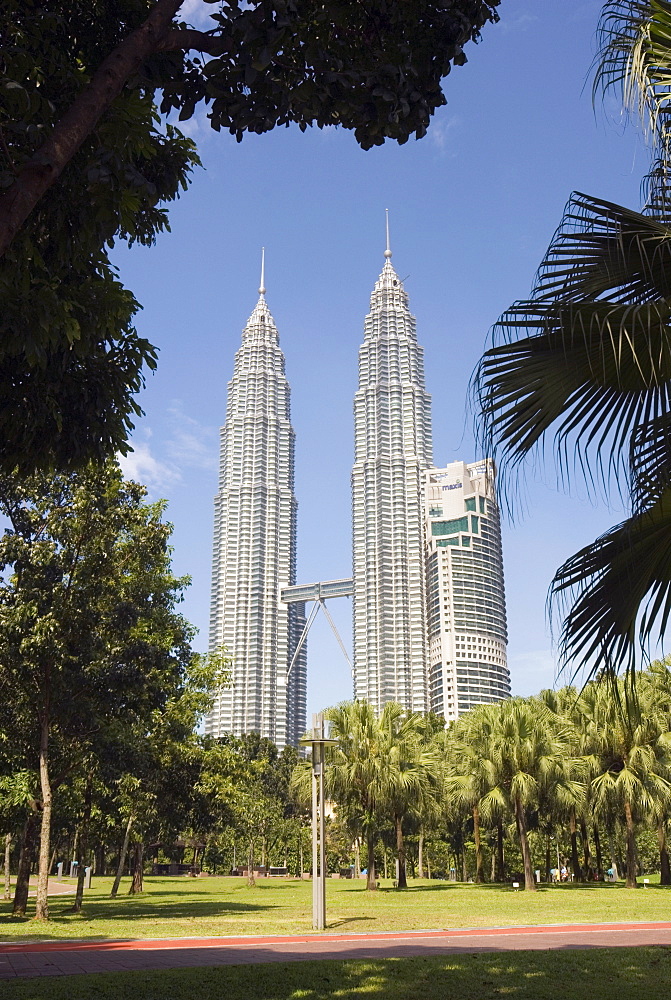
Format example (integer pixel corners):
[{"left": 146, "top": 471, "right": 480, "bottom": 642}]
[{"left": 0, "top": 921, "right": 671, "bottom": 954}]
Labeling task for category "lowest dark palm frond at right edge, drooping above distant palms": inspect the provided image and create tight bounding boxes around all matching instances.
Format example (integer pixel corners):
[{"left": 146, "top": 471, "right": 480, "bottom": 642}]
[{"left": 551, "top": 488, "right": 671, "bottom": 679}]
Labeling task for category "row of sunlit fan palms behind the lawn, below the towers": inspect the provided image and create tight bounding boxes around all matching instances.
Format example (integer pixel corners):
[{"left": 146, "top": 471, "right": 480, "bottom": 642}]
[{"left": 292, "top": 661, "right": 671, "bottom": 891}]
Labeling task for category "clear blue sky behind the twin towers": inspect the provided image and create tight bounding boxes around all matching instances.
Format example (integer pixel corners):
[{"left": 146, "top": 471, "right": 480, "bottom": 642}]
[{"left": 115, "top": 0, "right": 647, "bottom": 711}]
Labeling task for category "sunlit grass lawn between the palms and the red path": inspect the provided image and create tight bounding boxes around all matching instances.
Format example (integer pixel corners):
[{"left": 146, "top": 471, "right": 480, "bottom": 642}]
[{"left": 0, "top": 877, "right": 671, "bottom": 941}]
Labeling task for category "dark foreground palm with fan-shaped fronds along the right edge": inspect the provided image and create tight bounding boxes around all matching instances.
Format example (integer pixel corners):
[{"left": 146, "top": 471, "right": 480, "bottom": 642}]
[{"left": 474, "top": 0, "right": 671, "bottom": 679}]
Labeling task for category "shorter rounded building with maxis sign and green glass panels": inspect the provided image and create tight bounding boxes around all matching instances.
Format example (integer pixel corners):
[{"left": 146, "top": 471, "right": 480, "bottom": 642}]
[{"left": 425, "top": 461, "right": 510, "bottom": 721}]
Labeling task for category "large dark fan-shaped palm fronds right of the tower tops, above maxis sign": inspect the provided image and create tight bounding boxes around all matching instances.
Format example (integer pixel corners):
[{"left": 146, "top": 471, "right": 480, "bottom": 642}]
[{"left": 473, "top": 195, "right": 671, "bottom": 504}]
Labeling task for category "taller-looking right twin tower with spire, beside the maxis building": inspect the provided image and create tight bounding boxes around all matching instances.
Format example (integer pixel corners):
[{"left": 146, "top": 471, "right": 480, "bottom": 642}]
[{"left": 352, "top": 236, "right": 432, "bottom": 712}]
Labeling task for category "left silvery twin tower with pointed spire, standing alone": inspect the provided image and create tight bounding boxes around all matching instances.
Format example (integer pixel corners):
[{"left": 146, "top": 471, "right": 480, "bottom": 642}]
[{"left": 205, "top": 270, "right": 307, "bottom": 747}]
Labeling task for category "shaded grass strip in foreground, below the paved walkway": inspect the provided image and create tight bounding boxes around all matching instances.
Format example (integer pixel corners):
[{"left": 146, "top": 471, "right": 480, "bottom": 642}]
[{"left": 2, "top": 948, "right": 671, "bottom": 1000}]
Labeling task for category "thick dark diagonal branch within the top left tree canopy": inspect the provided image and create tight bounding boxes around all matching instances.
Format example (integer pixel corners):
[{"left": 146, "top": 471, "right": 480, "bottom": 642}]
[{"left": 0, "top": 0, "right": 184, "bottom": 257}]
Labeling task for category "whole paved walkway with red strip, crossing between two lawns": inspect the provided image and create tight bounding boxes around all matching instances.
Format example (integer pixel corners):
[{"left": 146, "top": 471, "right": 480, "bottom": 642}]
[{"left": 0, "top": 923, "right": 671, "bottom": 979}]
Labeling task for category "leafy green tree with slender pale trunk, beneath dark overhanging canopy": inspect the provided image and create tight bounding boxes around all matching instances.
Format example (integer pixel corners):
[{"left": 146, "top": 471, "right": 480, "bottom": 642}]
[{"left": 0, "top": 462, "right": 200, "bottom": 919}]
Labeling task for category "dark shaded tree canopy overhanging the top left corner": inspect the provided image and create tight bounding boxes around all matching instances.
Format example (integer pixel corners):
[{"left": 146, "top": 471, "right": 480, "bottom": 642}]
[{"left": 0, "top": 0, "right": 499, "bottom": 472}]
